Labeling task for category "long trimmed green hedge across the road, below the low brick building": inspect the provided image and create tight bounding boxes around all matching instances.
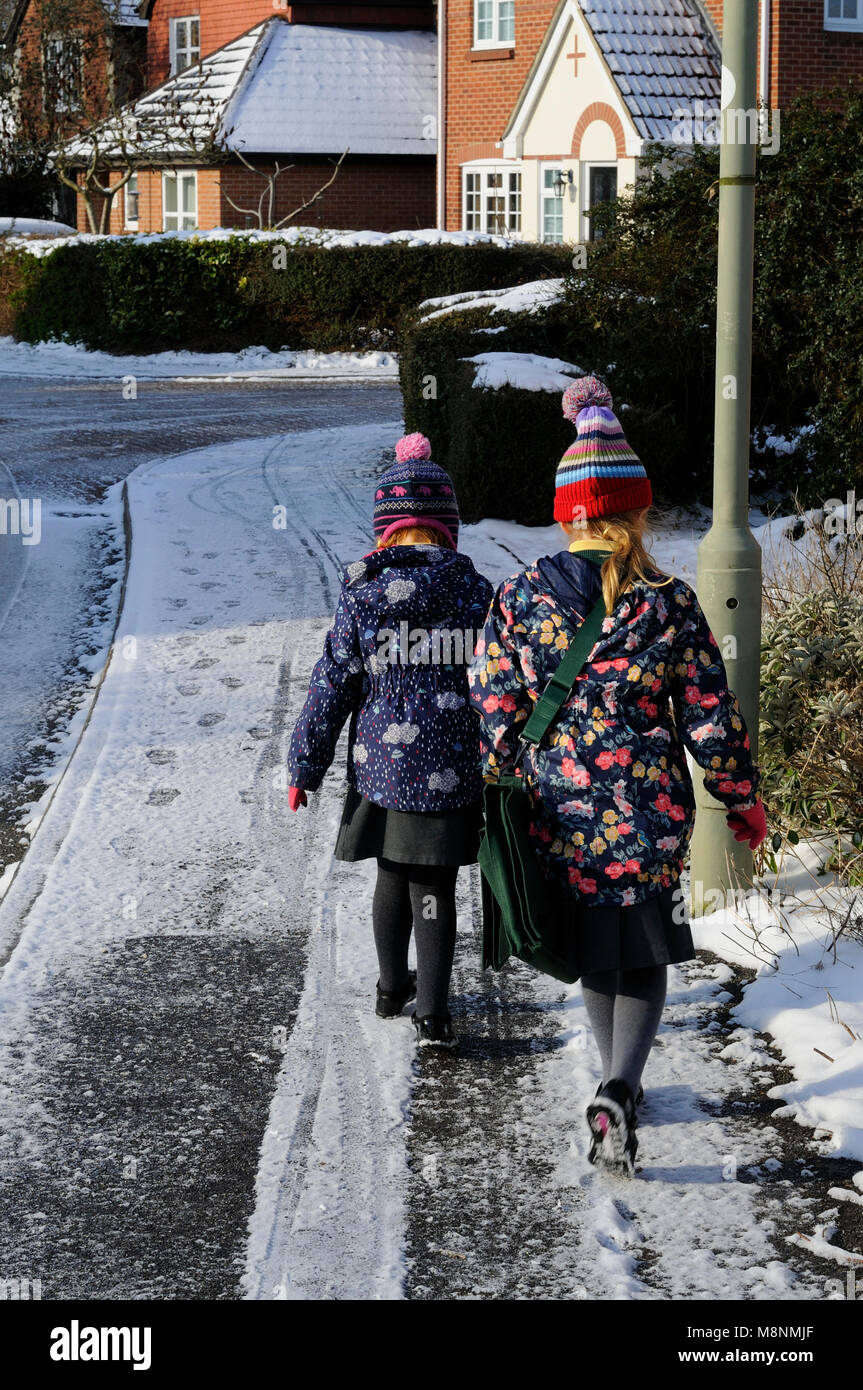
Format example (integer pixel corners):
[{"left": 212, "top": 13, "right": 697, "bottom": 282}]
[{"left": 7, "top": 236, "right": 568, "bottom": 352}]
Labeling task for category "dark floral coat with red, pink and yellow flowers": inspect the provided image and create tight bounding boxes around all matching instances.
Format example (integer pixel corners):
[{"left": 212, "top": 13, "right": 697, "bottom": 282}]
[{"left": 468, "top": 552, "right": 759, "bottom": 905}]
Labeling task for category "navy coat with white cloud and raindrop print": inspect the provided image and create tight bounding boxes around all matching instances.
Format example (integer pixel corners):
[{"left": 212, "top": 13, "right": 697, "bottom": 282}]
[{"left": 288, "top": 545, "right": 493, "bottom": 812}]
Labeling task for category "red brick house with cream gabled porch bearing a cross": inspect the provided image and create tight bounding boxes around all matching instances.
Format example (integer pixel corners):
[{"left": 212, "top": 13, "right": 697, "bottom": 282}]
[{"left": 438, "top": 0, "right": 863, "bottom": 242}]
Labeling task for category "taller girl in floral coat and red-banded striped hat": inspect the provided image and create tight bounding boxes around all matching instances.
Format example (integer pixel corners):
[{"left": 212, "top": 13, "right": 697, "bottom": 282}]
[{"left": 470, "top": 377, "right": 766, "bottom": 1172}]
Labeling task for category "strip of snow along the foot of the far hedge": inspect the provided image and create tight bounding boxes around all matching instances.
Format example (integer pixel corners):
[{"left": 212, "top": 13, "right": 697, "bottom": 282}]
[{"left": 0, "top": 336, "right": 399, "bottom": 382}]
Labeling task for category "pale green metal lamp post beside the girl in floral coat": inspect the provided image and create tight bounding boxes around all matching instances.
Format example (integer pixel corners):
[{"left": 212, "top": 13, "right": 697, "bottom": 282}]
[{"left": 691, "top": 0, "right": 762, "bottom": 915}]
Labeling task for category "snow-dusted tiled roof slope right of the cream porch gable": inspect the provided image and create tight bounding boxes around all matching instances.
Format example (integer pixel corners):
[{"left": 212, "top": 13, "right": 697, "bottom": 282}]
[{"left": 581, "top": 0, "right": 721, "bottom": 140}]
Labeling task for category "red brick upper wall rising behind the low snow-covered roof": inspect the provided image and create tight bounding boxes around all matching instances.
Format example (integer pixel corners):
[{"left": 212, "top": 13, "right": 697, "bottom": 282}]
[{"left": 149, "top": 0, "right": 434, "bottom": 86}]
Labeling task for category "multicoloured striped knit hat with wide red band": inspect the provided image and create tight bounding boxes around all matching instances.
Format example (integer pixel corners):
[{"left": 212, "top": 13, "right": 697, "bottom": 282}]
[{"left": 554, "top": 377, "right": 653, "bottom": 524}]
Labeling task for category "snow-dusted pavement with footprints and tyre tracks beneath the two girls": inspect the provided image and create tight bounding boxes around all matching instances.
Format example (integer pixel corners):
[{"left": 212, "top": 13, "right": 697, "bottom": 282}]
[{"left": 0, "top": 418, "right": 859, "bottom": 1300}]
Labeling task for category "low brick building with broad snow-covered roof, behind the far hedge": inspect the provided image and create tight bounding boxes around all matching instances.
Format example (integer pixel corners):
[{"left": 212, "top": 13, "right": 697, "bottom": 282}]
[{"left": 79, "top": 14, "right": 436, "bottom": 232}]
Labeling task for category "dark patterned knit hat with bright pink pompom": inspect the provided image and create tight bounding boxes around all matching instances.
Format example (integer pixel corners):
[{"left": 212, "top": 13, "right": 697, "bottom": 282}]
[{"left": 374, "top": 434, "right": 459, "bottom": 550}]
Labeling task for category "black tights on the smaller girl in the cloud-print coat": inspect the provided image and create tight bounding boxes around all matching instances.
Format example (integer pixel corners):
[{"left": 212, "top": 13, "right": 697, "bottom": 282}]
[{"left": 371, "top": 859, "right": 459, "bottom": 1019}]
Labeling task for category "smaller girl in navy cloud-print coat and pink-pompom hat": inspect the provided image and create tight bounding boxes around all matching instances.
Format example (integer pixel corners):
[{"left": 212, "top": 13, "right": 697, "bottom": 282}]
[{"left": 288, "top": 434, "right": 492, "bottom": 1047}]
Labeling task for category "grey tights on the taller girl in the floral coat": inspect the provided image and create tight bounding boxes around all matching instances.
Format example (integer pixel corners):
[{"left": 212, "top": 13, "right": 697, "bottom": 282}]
[{"left": 581, "top": 965, "right": 668, "bottom": 1095}]
